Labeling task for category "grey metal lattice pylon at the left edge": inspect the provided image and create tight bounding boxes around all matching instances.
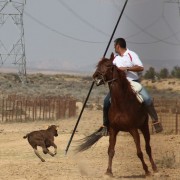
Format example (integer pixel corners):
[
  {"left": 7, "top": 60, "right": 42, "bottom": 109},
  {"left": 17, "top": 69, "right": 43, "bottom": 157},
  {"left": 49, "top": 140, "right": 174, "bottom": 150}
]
[{"left": 0, "top": 0, "right": 26, "bottom": 82}]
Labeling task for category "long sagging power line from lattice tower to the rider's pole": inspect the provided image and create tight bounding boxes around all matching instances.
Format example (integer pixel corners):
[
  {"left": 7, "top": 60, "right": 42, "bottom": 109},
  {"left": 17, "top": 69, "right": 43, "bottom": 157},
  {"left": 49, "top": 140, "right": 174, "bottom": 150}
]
[{"left": 24, "top": 11, "right": 106, "bottom": 44}]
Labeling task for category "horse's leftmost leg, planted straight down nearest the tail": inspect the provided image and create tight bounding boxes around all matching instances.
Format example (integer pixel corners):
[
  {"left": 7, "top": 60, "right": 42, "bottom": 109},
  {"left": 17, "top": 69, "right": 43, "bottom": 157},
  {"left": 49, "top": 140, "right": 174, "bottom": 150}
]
[{"left": 106, "top": 128, "right": 117, "bottom": 176}]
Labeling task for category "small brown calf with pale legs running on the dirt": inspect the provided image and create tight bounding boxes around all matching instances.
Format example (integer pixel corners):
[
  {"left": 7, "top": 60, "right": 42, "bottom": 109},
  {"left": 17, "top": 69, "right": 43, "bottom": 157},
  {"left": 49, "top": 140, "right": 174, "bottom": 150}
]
[{"left": 23, "top": 125, "right": 58, "bottom": 162}]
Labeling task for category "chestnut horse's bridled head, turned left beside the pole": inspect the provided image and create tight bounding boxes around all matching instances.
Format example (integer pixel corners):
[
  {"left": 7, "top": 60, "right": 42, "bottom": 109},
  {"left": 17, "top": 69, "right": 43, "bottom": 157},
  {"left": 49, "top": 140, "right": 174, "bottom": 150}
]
[{"left": 93, "top": 53, "right": 114, "bottom": 86}]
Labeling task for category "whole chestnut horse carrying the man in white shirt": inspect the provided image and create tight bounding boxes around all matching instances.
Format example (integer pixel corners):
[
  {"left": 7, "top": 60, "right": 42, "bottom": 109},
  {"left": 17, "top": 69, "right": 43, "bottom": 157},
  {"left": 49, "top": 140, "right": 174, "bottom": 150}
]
[{"left": 78, "top": 53, "right": 157, "bottom": 175}]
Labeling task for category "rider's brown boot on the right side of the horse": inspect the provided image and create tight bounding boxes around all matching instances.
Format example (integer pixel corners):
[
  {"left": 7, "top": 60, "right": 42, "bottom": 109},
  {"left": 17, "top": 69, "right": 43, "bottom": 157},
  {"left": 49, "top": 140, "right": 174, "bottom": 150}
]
[{"left": 146, "top": 103, "right": 163, "bottom": 133}]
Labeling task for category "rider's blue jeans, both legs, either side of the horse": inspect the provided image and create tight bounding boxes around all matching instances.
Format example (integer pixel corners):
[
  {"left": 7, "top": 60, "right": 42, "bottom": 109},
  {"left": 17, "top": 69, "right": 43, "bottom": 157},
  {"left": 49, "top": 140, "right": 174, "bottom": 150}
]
[{"left": 103, "top": 86, "right": 152, "bottom": 126}]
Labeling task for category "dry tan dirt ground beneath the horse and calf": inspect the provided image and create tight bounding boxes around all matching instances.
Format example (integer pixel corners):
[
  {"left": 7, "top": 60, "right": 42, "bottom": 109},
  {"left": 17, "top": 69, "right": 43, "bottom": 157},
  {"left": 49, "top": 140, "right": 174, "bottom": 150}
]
[{"left": 0, "top": 109, "right": 180, "bottom": 180}]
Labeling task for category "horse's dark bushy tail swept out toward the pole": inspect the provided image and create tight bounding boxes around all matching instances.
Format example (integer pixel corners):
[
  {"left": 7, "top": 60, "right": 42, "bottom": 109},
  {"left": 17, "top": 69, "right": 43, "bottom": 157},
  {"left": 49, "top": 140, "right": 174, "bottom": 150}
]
[{"left": 76, "top": 130, "right": 104, "bottom": 152}]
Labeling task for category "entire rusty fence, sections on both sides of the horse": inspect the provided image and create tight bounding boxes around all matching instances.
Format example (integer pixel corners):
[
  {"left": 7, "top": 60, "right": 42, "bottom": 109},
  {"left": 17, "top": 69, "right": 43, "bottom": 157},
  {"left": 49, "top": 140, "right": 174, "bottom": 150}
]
[{"left": 0, "top": 95, "right": 180, "bottom": 134}]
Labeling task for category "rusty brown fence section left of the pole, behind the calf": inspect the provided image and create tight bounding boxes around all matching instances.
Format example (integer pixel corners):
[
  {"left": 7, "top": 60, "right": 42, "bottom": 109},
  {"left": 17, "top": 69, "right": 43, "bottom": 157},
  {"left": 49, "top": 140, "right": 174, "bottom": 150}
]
[{"left": 0, "top": 95, "right": 76, "bottom": 122}]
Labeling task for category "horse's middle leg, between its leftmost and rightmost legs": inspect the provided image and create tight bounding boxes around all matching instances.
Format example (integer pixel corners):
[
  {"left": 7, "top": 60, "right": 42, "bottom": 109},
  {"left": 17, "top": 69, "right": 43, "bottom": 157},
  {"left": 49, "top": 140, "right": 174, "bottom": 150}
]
[{"left": 130, "top": 129, "right": 150, "bottom": 175}]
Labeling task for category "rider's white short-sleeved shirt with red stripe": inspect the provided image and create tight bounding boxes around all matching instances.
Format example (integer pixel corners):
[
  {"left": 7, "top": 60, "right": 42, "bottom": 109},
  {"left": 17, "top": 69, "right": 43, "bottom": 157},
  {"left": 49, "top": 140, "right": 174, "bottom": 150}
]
[{"left": 113, "top": 49, "right": 143, "bottom": 80}]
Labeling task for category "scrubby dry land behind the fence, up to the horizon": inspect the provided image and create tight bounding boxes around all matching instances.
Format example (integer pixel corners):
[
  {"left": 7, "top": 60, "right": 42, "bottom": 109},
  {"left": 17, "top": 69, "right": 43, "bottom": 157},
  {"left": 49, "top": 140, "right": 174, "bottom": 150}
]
[{"left": 0, "top": 71, "right": 180, "bottom": 102}]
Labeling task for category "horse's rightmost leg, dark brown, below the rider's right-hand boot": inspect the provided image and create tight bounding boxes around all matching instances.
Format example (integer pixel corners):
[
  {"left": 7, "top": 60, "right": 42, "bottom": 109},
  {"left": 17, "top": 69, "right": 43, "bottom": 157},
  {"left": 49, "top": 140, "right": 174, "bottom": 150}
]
[{"left": 140, "top": 121, "right": 157, "bottom": 172}]
